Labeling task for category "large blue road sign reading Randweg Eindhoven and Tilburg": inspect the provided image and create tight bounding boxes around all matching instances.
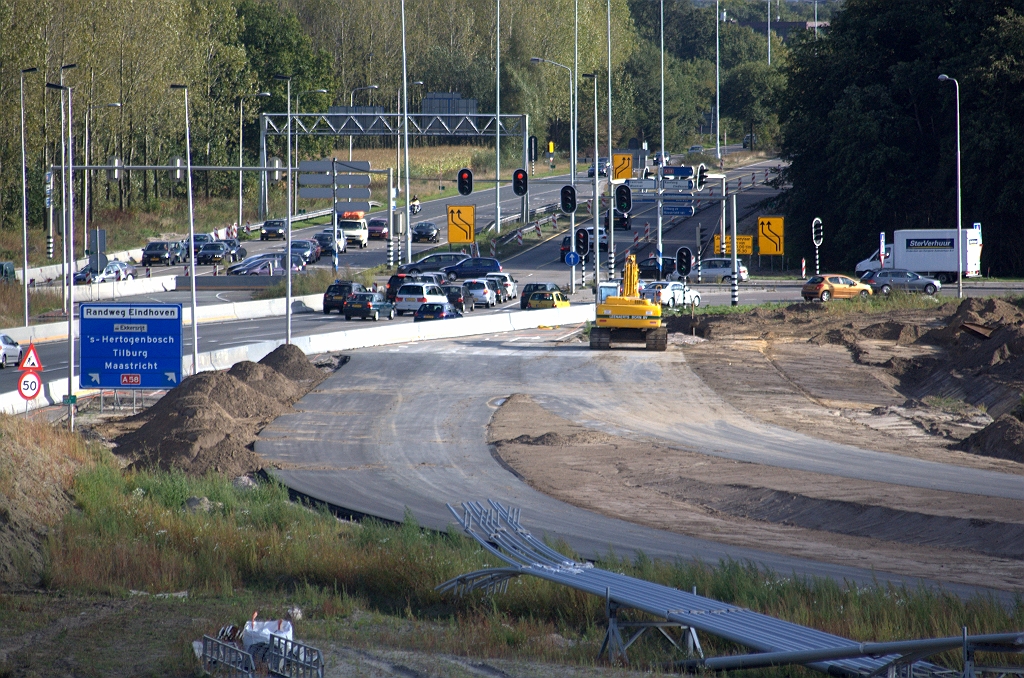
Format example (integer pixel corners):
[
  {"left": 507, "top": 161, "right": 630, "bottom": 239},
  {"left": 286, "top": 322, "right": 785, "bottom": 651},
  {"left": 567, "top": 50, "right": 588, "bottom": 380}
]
[{"left": 79, "top": 303, "right": 181, "bottom": 388}]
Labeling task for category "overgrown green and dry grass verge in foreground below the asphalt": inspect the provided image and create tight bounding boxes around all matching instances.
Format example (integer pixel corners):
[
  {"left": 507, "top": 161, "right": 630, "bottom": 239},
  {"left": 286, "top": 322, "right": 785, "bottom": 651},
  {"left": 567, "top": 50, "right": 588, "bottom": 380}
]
[{"left": 0, "top": 448, "right": 1024, "bottom": 676}]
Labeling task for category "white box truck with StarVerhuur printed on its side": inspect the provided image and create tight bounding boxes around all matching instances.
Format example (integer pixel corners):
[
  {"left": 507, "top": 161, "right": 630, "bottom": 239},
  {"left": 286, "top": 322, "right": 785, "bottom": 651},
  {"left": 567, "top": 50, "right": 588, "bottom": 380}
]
[{"left": 857, "top": 228, "right": 982, "bottom": 283}]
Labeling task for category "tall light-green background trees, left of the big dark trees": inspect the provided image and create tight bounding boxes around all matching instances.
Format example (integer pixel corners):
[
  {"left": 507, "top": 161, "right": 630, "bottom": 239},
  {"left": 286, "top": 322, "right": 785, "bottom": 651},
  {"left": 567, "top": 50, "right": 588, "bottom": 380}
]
[{"left": 0, "top": 0, "right": 815, "bottom": 242}]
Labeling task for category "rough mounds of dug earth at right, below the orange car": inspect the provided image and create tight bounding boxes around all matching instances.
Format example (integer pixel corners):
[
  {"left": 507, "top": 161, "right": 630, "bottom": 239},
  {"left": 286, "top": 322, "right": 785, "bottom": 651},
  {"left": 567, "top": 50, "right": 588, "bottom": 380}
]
[{"left": 669, "top": 298, "right": 1024, "bottom": 461}]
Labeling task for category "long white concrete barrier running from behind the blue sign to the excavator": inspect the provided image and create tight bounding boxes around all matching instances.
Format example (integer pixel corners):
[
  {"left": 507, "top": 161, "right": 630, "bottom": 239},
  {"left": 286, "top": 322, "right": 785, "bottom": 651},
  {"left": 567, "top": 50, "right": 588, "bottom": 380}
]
[{"left": 0, "top": 307, "right": 595, "bottom": 414}]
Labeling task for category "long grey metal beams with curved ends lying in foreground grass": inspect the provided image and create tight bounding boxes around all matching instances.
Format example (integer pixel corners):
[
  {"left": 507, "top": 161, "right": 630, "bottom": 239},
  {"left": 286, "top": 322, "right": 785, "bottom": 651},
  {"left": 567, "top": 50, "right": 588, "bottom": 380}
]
[{"left": 437, "top": 501, "right": 1024, "bottom": 678}]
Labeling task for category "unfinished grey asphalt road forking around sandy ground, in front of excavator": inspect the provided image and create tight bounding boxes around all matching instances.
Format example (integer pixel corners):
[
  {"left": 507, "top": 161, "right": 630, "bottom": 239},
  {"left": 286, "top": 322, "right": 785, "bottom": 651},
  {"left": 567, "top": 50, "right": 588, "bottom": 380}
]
[{"left": 256, "top": 329, "right": 1024, "bottom": 593}]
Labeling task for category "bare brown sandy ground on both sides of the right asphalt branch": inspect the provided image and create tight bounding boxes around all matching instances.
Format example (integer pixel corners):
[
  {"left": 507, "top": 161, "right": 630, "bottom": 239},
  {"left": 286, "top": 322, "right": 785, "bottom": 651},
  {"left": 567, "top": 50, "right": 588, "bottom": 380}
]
[{"left": 490, "top": 301, "right": 1024, "bottom": 590}]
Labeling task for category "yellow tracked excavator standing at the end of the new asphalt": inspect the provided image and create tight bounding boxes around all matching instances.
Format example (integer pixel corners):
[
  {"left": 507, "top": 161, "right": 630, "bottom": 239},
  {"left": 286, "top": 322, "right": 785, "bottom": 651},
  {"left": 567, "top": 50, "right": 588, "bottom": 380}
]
[{"left": 590, "top": 254, "right": 669, "bottom": 350}]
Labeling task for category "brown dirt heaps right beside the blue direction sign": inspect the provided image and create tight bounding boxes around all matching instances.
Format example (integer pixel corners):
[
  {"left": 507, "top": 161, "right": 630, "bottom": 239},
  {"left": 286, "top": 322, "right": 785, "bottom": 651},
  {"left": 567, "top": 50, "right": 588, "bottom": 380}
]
[{"left": 115, "top": 345, "right": 326, "bottom": 476}]
